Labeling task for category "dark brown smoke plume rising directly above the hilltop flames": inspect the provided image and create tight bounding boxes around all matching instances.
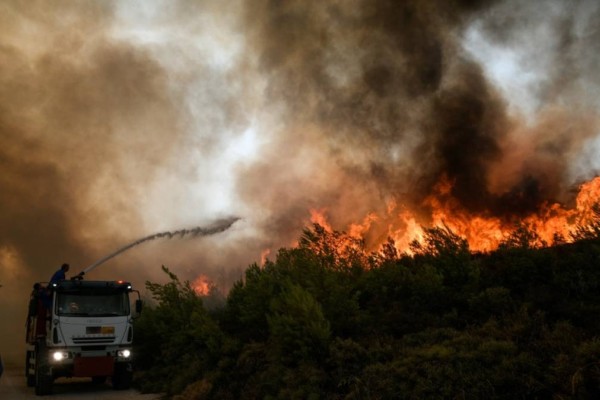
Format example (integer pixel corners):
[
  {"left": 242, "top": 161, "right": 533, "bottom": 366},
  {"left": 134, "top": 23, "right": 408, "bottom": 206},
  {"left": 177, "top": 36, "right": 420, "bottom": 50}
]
[{"left": 240, "top": 0, "right": 600, "bottom": 230}]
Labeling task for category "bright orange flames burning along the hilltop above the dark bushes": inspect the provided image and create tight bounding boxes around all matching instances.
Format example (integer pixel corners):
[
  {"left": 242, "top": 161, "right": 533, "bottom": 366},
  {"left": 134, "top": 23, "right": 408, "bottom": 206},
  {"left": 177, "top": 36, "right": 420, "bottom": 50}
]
[{"left": 310, "top": 177, "right": 600, "bottom": 252}]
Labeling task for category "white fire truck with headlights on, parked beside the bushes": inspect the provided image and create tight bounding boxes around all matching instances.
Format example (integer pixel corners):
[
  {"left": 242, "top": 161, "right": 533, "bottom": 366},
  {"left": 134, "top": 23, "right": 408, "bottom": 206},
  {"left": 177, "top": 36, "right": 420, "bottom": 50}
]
[{"left": 25, "top": 279, "right": 142, "bottom": 396}]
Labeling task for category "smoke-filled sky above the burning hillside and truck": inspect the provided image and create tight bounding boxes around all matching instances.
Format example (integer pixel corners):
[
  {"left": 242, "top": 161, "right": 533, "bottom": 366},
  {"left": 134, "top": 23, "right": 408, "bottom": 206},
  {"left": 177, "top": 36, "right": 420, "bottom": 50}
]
[{"left": 0, "top": 0, "right": 600, "bottom": 358}]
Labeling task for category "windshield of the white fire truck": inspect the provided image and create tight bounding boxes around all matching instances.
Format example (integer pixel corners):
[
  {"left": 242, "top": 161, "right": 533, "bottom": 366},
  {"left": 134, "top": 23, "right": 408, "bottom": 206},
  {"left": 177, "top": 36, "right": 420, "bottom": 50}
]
[{"left": 56, "top": 293, "right": 129, "bottom": 317}]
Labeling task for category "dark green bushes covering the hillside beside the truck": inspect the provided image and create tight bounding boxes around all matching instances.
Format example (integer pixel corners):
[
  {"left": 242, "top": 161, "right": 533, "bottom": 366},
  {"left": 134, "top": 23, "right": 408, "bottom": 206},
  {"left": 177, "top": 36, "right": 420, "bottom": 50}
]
[{"left": 136, "top": 220, "right": 600, "bottom": 400}]
